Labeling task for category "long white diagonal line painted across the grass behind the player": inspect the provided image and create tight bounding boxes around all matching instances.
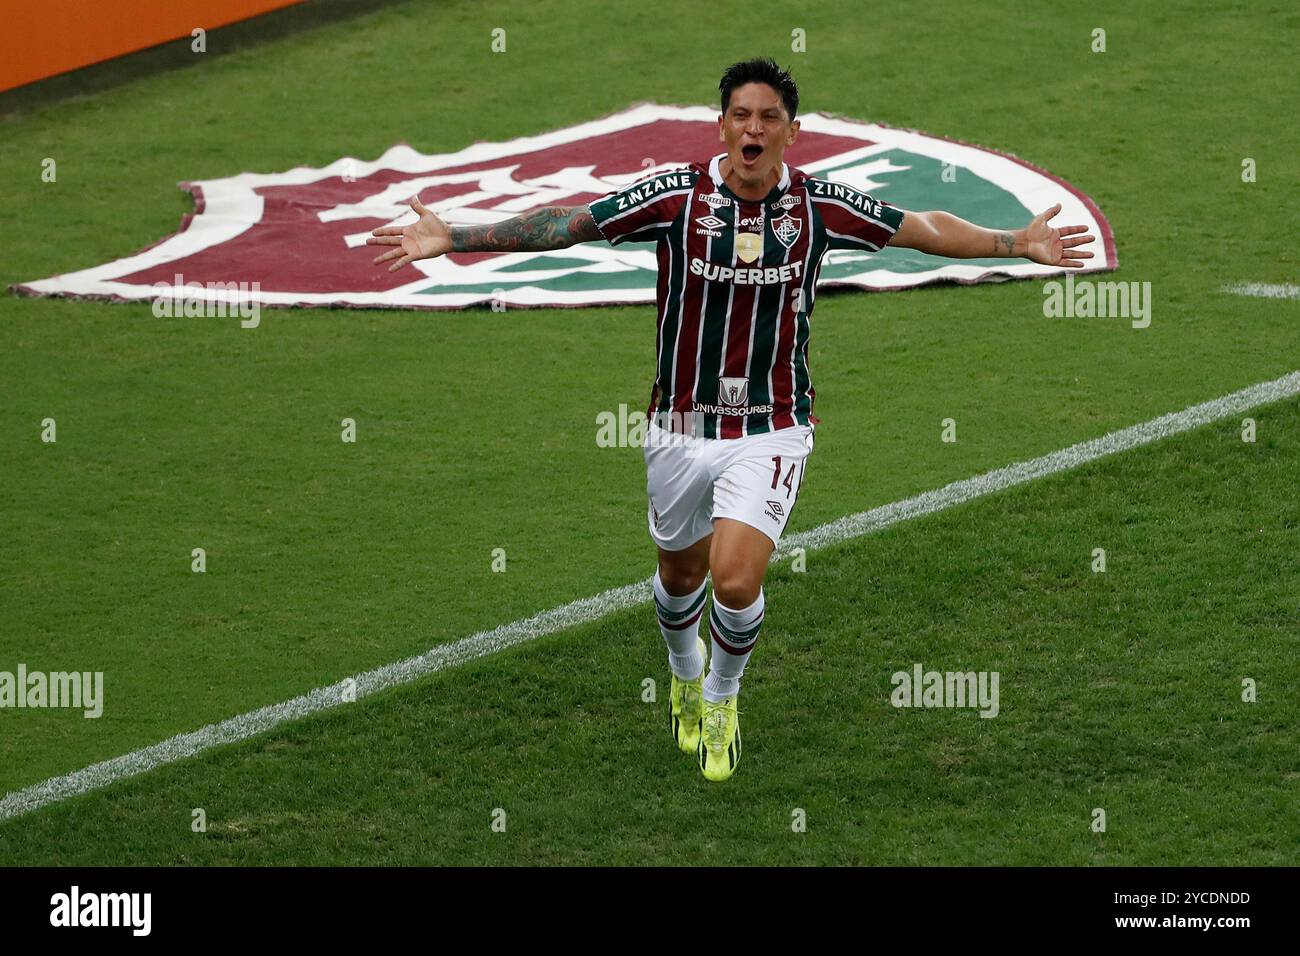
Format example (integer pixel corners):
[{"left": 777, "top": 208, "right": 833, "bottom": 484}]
[{"left": 0, "top": 371, "right": 1300, "bottom": 821}]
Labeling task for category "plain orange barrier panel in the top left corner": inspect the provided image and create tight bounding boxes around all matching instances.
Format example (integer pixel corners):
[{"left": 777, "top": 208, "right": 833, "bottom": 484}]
[{"left": 0, "top": 0, "right": 302, "bottom": 90}]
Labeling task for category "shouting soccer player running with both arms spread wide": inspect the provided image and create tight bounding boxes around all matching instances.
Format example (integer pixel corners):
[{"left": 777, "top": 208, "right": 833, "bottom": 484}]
[{"left": 368, "top": 59, "right": 1093, "bottom": 780}]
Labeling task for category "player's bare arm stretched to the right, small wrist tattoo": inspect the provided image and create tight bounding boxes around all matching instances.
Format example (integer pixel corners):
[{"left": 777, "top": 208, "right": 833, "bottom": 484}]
[{"left": 889, "top": 203, "right": 1093, "bottom": 269}]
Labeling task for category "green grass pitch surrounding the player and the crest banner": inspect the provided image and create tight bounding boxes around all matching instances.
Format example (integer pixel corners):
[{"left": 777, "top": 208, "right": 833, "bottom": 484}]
[{"left": 0, "top": 0, "right": 1300, "bottom": 865}]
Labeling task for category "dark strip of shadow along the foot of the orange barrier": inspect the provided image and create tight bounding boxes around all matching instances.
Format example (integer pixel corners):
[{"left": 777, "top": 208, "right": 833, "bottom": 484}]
[{"left": 0, "top": 0, "right": 410, "bottom": 116}]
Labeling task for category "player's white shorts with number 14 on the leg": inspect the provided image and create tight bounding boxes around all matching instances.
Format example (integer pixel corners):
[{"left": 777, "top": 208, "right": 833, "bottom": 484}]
[{"left": 645, "top": 420, "right": 813, "bottom": 551}]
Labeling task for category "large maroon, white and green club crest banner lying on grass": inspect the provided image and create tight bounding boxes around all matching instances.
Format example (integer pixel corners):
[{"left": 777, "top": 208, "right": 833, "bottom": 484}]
[{"left": 16, "top": 104, "right": 1117, "bottom": 308}]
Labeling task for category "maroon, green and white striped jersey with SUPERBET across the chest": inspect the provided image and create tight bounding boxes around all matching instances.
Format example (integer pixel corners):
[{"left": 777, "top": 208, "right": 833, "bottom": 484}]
[{"left": 590, "top": 155, "right": 904, "bottom": 438}]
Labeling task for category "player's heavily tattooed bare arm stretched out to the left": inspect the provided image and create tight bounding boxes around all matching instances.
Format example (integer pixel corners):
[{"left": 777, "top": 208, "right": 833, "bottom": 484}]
[{"left": 365, "top": 196, "right": 603, "bottom": 272}]
